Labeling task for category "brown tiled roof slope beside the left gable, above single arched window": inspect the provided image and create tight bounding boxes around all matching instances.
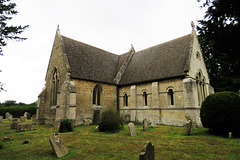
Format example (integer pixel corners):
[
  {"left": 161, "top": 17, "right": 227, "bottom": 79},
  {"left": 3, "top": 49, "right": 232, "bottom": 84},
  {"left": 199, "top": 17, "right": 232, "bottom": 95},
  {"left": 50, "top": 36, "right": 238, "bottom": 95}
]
[{"left": 62, "top": 36, "right": 118, "bottom": 84}]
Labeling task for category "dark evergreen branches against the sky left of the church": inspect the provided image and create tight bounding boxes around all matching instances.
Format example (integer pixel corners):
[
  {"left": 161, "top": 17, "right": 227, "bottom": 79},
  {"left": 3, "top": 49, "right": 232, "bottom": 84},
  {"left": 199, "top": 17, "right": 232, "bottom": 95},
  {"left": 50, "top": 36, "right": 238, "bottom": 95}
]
[{"left": 0, "top": 0, "right": 29, "bottom": 92}]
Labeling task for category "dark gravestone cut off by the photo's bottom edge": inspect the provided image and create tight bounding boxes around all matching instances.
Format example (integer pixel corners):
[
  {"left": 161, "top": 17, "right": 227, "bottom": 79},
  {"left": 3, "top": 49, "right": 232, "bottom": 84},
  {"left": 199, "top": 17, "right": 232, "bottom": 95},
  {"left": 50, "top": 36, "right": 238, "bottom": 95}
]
[{"left": 139, "top": 141, "right": 155, "bottom": 160}]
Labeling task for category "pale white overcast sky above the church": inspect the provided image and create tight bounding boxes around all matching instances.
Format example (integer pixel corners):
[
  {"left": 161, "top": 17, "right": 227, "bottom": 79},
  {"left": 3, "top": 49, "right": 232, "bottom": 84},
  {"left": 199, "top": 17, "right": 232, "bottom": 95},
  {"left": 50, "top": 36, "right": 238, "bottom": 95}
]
[{"left": 0, "top": 0, "right": 205, "bottom": 103}]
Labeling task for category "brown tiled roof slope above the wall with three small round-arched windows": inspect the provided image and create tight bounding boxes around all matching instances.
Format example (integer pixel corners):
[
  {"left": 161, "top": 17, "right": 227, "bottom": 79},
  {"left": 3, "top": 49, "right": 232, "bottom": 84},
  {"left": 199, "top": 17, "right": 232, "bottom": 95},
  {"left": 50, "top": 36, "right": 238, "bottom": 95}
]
[{"left": 119, "top": 34, "right": 192, "bottom": 85}]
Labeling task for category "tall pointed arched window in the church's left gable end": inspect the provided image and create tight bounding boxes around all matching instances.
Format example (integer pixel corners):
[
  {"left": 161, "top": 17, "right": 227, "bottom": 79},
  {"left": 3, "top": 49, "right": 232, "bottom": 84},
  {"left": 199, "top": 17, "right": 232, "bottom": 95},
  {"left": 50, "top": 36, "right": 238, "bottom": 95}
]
[{"left": 52, "top": 69, "right": 59, "bottom": 106}]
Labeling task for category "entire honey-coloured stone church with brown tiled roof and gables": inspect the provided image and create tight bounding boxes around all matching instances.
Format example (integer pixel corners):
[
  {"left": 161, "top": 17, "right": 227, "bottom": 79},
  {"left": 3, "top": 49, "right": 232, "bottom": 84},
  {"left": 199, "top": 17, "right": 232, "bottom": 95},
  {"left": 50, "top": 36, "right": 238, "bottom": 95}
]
[{"left": 37, "top": 24, "right": 214, "bottom": 126}]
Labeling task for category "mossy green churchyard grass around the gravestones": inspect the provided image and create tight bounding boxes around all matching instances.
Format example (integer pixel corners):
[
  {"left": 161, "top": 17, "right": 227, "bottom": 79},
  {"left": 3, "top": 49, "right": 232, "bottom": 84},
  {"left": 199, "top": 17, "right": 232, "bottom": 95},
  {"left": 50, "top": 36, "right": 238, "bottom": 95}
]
[{"left": 0, "top": 122, "right": 240, "bottom": 160}]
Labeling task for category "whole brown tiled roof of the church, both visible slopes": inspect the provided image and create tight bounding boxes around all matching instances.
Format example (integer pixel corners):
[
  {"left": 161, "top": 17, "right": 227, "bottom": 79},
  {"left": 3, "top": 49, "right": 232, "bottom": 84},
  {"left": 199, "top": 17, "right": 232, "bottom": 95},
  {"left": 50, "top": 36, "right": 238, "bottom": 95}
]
[{"left": 62, "top": 34, "right": 192, "bottom": 85}]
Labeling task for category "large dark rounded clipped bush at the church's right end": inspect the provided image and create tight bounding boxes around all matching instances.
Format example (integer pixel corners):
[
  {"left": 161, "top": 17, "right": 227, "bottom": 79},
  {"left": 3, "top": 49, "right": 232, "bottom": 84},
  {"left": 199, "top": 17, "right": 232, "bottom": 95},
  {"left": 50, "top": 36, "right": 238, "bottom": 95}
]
[{"left": 200, "top": 92, "right": 240, "bottom": 135}]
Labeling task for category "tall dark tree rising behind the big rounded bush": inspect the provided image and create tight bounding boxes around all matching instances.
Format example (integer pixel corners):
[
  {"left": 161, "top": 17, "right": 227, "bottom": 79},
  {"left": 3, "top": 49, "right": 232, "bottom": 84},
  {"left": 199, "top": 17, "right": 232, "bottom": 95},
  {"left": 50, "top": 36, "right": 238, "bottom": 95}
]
[{"left": 197, "top": 0, "right": 240, "bottom": 92}]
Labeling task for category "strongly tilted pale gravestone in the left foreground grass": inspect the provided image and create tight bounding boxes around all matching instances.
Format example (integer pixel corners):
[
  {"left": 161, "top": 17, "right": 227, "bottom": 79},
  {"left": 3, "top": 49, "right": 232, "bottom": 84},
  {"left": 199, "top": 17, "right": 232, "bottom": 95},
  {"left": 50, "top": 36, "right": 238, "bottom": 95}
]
[{"left": 49, "top": 133, "right": 68, "bottom": 158}]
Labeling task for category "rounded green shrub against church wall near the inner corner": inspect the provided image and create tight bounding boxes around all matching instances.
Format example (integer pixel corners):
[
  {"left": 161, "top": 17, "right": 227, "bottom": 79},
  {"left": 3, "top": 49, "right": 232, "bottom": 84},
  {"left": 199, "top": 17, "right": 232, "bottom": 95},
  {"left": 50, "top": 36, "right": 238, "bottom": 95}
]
[{"left": 99, "top": 109, "right": 123, "bottom": 132}]
